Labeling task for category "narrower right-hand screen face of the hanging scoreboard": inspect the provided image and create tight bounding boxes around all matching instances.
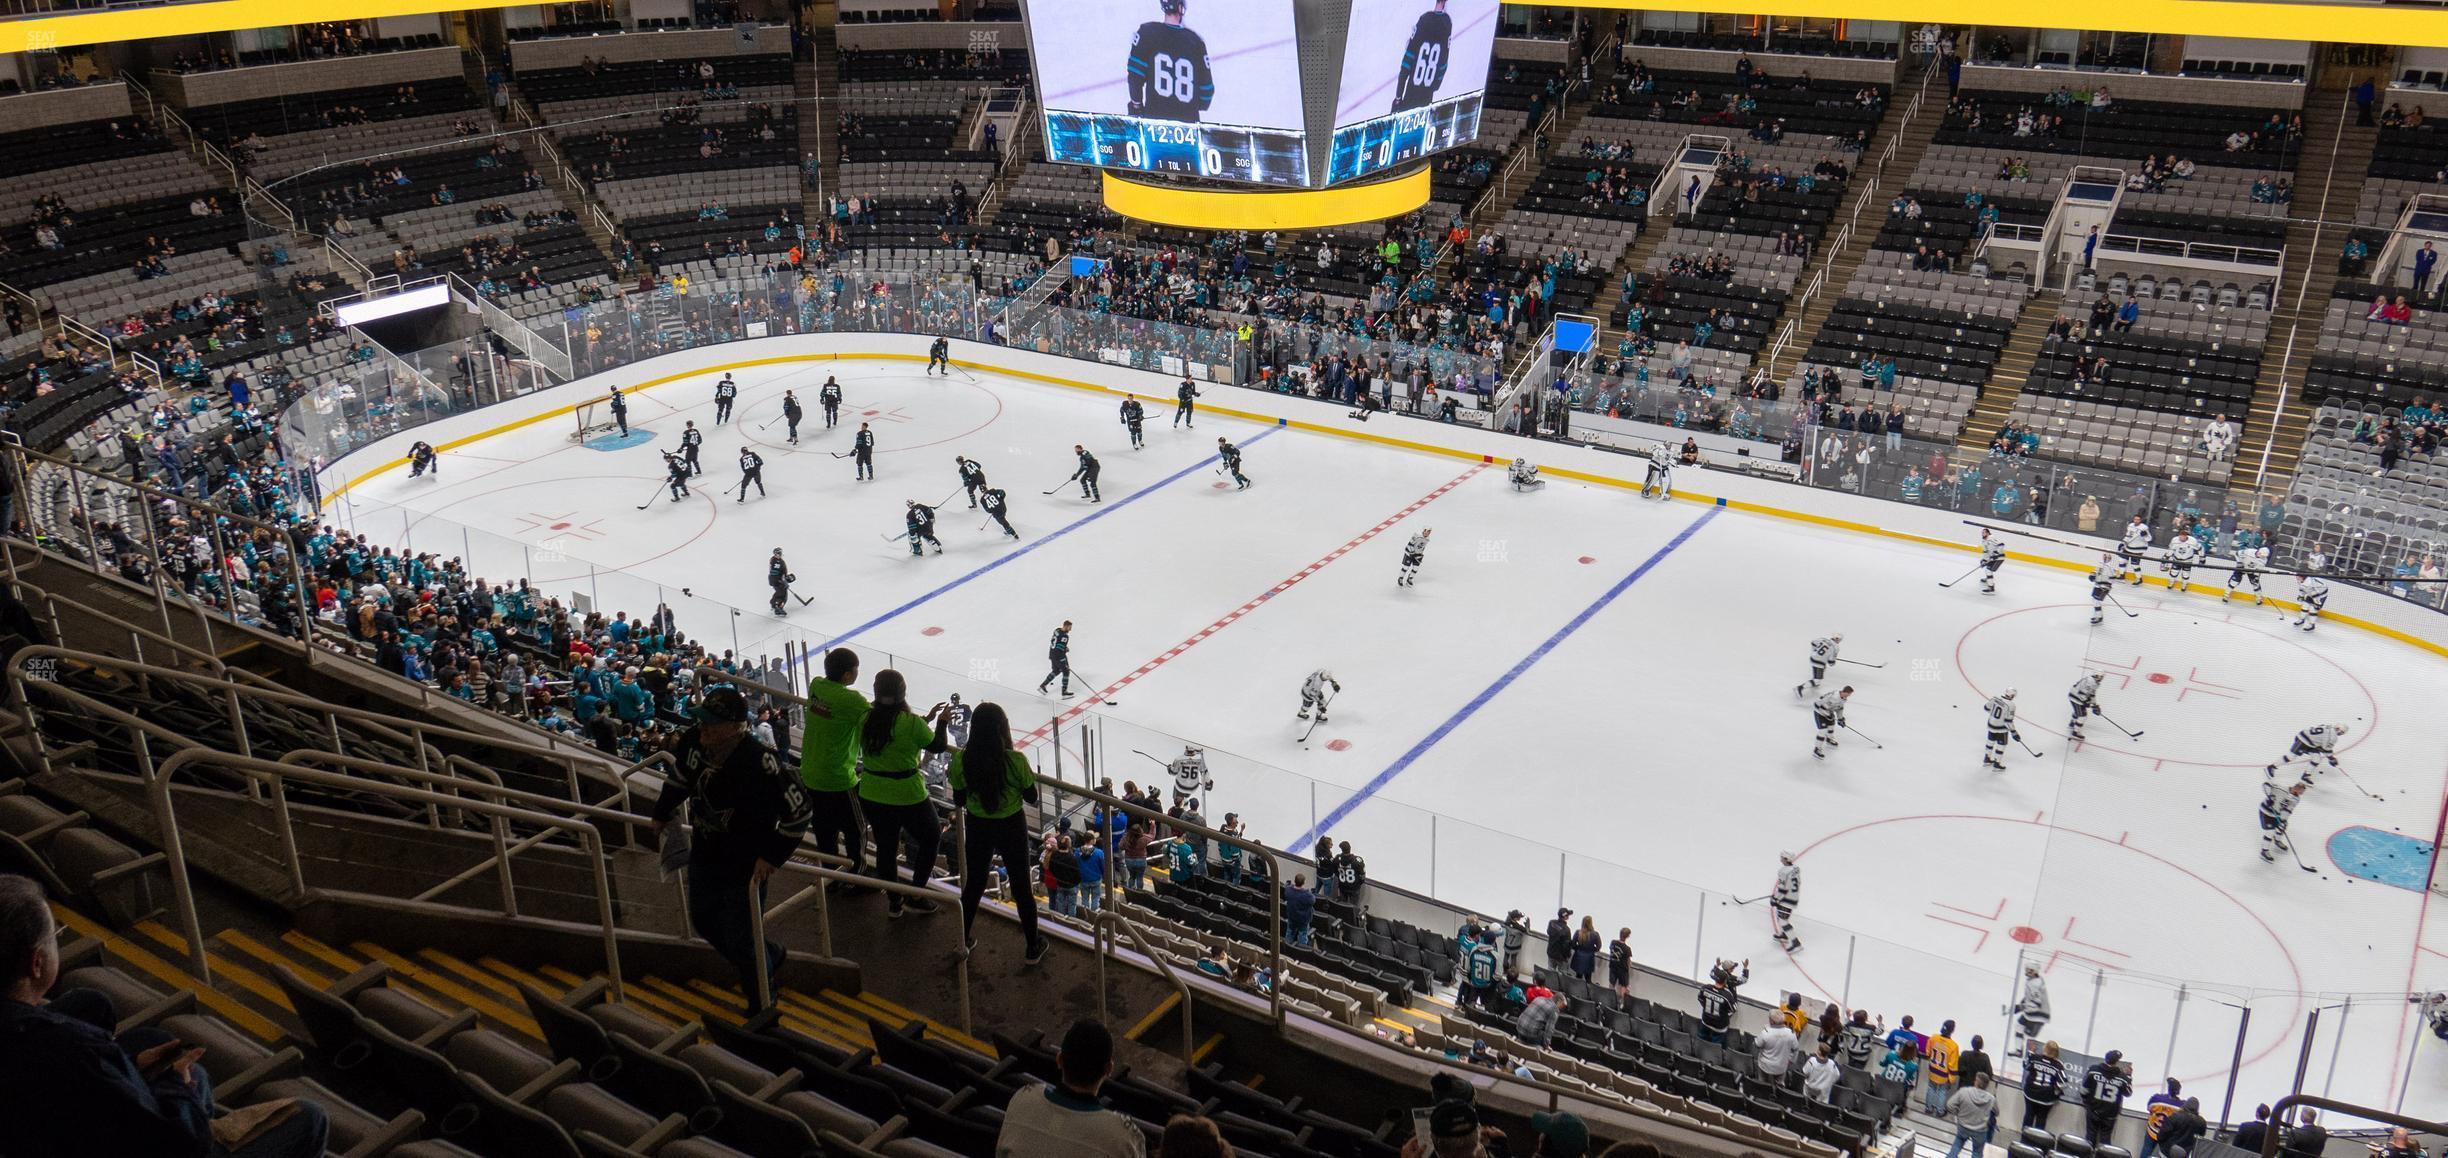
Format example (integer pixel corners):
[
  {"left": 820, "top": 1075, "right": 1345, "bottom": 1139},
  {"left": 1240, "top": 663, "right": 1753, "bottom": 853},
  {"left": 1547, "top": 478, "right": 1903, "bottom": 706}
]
[{"left": 1327, "top": 0, "right": 1498, "bottom": 184}]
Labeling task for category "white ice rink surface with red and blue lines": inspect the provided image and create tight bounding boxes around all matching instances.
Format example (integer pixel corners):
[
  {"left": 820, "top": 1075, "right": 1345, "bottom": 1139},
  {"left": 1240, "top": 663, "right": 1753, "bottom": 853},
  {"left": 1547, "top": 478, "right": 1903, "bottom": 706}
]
[{"left": 328, "top": 357, "right": 2448, "bottom": 1116}]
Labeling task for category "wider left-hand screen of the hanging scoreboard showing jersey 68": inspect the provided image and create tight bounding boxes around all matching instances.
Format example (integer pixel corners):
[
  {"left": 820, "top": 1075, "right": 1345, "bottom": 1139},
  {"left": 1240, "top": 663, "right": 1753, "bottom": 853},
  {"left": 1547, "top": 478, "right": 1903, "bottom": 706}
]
[{"left": 1028, "top": 0, "right": 1312, "bottom": 186}]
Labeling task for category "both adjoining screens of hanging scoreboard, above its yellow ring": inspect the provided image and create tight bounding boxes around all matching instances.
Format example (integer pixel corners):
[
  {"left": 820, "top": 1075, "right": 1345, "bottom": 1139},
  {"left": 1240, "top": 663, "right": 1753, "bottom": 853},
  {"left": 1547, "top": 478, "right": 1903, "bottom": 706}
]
[{"left": 1026, "top": 0, "right": 1498, "bottom": 189}]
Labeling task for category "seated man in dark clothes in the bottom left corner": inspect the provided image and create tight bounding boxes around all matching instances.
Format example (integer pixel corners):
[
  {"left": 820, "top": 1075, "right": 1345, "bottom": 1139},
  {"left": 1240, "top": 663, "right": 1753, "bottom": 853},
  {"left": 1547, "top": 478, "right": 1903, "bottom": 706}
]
[{"left": 0, "top": 876, "right": 330, "bottom": 1158}]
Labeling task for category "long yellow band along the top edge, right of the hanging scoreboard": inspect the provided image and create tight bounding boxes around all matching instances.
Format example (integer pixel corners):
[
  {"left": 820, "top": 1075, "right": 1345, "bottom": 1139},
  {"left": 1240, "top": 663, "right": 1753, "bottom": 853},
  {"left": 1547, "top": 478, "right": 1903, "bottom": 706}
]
[{"left": 1540, "top": 0, "right": 2448, "bottom": 49}]
